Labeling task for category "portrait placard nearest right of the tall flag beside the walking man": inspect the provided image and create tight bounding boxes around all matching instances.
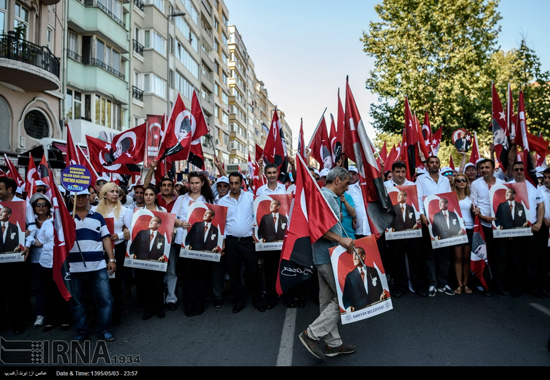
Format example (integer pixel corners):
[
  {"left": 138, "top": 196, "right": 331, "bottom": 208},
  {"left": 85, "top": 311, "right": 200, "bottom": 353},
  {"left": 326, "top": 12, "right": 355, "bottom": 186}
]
[{"left": 386, "top": 186, "right": 422, "bottom": 240}]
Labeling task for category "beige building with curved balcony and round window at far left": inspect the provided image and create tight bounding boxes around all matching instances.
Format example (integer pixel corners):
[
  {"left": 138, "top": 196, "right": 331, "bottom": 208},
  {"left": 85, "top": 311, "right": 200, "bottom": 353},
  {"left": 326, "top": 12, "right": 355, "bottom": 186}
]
[{"left": 0, "top": 0, "right": 65, "bottom": 165}]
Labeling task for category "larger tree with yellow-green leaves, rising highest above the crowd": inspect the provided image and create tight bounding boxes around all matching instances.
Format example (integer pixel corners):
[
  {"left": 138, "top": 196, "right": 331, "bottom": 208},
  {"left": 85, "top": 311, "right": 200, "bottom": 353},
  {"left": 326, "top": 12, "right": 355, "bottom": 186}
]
[{"left": 362, "top": 0, "right": 501, "bottom": 140}]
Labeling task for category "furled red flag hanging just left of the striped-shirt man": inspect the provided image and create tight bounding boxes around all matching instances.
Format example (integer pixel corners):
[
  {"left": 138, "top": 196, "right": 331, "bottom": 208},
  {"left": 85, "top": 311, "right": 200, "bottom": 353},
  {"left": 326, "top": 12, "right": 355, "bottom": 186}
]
[{"left": 49, "top": 170, "right": 76, "bottom": 301}]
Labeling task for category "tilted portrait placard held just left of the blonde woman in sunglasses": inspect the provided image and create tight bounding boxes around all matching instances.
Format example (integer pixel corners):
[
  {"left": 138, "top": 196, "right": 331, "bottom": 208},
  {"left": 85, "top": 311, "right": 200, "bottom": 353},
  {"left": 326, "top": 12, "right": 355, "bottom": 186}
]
[{"left": 424, "top": 192, "right": 468, "bottom": 249}]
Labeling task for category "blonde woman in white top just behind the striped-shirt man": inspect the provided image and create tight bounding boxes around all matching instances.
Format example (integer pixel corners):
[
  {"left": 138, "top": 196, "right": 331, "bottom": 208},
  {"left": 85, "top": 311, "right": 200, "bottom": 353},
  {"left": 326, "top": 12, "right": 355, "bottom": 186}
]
[{"left": 95, "top": 182, "right": 132, "bottom": 325}]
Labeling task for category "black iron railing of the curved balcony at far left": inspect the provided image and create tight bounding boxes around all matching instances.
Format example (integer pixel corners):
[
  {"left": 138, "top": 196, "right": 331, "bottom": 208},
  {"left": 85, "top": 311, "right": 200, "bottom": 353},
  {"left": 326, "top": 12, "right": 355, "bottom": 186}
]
[{"left": 0, "top": 32, "right": 59, "bottom": 78}]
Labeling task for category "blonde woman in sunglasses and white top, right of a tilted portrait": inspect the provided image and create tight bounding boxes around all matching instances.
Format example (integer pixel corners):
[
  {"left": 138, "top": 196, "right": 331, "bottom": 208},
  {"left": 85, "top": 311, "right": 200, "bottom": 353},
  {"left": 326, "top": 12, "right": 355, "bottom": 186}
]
[{"left": 452, "top": 173, "right": 474, "bottom": 294}]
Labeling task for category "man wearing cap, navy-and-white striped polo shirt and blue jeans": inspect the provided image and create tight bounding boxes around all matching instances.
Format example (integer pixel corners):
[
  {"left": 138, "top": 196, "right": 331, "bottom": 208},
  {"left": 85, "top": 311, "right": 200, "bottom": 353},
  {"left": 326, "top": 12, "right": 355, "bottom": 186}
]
[{"left": 69, "top": 190, "right": 116, "bottom": 342}]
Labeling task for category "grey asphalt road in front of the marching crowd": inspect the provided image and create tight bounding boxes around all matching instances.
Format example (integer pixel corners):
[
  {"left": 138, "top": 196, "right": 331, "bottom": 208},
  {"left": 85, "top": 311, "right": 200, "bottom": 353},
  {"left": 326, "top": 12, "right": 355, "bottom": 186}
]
[{"left": 2, "top": 284, "right": 550, "bottom": 370}]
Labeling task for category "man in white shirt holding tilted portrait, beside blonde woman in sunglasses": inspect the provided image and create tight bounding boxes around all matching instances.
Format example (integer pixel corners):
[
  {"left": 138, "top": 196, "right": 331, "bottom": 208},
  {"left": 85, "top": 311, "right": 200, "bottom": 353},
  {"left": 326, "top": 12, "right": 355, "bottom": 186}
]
[{"left": 416, "top": 156, "right": 454, "bottom": 297}]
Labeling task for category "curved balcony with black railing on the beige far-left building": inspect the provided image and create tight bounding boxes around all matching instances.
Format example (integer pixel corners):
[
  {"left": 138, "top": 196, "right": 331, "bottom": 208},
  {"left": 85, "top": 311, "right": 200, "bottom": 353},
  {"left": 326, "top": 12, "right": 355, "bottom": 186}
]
[{"left": 0, "top": 32, "right": 60, "bottom": 91}]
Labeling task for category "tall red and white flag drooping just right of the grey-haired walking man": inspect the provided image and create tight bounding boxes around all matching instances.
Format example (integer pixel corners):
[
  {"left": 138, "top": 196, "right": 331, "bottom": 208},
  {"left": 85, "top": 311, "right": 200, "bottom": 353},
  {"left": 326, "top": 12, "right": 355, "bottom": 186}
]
[{"left": 346, "top": 78, "right": 395, "bottom": 239}]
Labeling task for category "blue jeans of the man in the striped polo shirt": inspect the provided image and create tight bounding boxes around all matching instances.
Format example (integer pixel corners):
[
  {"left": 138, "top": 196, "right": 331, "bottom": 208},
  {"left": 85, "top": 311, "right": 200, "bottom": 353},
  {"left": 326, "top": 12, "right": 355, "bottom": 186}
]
[{"left": 71, "top": 269, "right": 113, "bottom": 335}]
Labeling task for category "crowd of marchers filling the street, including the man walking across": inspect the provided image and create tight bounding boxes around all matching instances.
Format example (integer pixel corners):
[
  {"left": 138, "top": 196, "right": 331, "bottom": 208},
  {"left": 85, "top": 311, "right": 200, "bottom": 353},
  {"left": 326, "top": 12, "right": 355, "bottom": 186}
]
[{"left": 0, "top": 142, "right": 550, "bottom": 358}]
